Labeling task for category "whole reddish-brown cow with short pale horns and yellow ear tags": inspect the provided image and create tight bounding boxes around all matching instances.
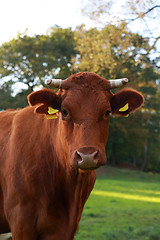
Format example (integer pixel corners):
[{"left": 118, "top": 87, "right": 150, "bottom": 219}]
[{"left": 0, "top": 73, "right": 143, "bottom": 240}]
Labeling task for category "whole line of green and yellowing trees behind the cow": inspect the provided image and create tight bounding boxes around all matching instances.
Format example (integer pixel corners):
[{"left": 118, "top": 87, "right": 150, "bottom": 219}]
[{"left": 0, "top": 7, "right": 160, "bottom": 172}]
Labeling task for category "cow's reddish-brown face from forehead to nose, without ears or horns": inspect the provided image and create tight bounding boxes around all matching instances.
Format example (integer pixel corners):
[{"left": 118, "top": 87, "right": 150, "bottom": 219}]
[{"left": 59, "top": 84, "right": 111, "bottom": 169}]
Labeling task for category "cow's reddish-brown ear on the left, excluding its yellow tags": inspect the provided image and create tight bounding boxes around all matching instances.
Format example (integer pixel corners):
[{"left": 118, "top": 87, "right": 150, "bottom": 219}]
[{"left": 28, "top": 89, "right": 61, "bottom": 115}]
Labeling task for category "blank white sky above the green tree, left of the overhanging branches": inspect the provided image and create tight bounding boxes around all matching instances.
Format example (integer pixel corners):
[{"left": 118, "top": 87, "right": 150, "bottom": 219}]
[{"left": 0, "top": 0, "right": 88, "bottom": 44}]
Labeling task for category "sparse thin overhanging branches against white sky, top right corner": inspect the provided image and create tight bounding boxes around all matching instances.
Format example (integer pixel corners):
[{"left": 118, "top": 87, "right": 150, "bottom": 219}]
[{"left": 82, "top": 0, "right": 160, "bottom": 53}]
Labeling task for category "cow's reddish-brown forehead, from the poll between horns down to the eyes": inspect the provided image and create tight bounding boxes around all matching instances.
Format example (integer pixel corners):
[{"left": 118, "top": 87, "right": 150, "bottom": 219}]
[{"left": 57, "top": 73, "right": 112, "bottom": 114}]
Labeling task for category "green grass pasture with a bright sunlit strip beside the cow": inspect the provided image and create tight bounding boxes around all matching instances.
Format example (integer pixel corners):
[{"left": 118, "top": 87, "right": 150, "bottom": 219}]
[{"left": 75, "top": 167, "right": 160, "bottom": 240}]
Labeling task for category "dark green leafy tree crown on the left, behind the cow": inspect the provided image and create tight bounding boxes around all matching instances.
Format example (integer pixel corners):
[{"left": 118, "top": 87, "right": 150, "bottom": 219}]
[{"left": 0, "top": 26, "right": 76, "bottom": 91}]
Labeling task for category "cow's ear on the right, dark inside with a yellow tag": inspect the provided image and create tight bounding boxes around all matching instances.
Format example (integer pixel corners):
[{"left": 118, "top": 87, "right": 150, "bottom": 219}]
[{"left": 111, "top": 89, "right": 144, "bottom": 116}]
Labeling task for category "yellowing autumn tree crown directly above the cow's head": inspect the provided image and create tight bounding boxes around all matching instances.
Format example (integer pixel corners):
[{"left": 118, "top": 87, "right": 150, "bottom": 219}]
[{"left": 73, "top": 24, "right": 150, "bottom": 82}]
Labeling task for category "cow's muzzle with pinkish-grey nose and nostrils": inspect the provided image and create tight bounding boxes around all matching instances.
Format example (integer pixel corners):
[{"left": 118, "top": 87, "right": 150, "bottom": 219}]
[{"left": 74, "top": 147, "right": 106, "bottom": 170}]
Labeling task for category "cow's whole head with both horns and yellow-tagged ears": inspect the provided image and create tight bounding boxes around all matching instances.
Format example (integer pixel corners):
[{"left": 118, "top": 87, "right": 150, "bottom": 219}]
[{"left": 28, "top": 73, "right": 143, "bottom": 170}]
